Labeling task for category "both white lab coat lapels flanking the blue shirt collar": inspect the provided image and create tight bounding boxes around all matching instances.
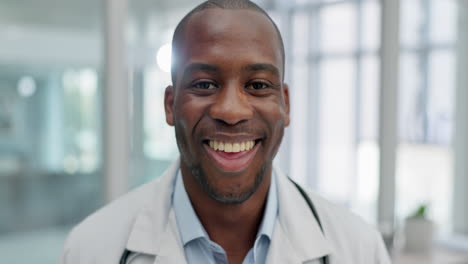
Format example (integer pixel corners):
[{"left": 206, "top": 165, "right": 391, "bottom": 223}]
[{"left": 122, "top": 159, "right": 332, "bottom": 264}]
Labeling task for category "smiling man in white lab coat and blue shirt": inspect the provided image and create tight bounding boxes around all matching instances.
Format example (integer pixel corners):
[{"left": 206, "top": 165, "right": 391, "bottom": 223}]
[{"left": 62, "top": 0, "right": 390, "bottom": 264}]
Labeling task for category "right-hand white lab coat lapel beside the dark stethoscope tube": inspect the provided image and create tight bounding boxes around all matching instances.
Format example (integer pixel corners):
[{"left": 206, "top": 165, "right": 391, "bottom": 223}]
[{"left": 267, "top": 168, "right": 332, "bottom": 264}]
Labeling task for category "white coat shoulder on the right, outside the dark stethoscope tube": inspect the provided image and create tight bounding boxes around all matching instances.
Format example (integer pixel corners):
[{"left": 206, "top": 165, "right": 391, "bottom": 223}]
[{"left": 307, "top": 190, "right": 390, "bottom": 264}]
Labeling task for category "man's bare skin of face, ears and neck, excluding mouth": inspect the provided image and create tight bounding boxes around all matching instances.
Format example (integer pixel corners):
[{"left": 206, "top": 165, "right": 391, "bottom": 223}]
[{"left": 165, "top": 8, "right": 289, "bottom": 263}]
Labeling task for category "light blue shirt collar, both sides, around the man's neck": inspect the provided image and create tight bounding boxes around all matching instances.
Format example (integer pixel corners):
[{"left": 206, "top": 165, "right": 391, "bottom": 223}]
[{"left": 173, "top": 170, "right": 278, "bottom": 245}]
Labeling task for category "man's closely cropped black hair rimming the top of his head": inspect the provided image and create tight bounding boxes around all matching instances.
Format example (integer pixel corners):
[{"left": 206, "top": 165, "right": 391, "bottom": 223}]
[{"left": 171, "top": 0, "right": 286, "bottom": 85}]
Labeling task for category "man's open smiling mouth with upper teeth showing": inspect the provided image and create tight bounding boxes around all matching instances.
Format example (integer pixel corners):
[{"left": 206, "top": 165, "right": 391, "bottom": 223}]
[{"left": 204, "top": 140, "right": 261, "bottom": 172}]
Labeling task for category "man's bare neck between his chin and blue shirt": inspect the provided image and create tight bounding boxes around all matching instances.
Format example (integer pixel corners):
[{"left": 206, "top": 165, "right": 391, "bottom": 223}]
[{"left": 181, "top": 164, "right": 271, "bottom": 258}]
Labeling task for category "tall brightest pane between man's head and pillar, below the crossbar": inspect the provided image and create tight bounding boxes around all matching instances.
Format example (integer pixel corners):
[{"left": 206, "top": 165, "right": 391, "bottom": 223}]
[{"left": 319, "top": 58, "right": 356, "bottom": 204}]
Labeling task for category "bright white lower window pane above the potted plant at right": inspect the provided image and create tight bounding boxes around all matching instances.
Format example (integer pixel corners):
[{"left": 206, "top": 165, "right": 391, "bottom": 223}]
[{"left": 396, "top": 144, "right": 453, "bottom": 233}]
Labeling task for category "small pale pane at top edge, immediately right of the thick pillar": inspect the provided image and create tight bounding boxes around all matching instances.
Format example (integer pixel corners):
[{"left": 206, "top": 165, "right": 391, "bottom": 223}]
[{"left": 400, "top": 0, "right": 425, "bottom": 48}]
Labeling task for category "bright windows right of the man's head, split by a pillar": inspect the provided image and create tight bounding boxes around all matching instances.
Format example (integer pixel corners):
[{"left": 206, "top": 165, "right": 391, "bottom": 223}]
[{"left": 285, "top": 0, "right": 457, "bottom": 237}]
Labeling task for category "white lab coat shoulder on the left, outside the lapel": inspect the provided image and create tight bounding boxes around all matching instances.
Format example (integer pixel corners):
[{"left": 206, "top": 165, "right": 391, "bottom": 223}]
[{"left": 62, "top": 179, "right": 160, "bottom": 263}]
